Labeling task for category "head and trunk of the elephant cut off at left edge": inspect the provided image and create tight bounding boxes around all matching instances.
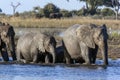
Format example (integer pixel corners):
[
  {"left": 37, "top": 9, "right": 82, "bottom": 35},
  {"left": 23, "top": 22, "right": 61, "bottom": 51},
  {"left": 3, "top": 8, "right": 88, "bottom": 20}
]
[{"left": 0, "top": 24, "right": 16, "bottom": 60}]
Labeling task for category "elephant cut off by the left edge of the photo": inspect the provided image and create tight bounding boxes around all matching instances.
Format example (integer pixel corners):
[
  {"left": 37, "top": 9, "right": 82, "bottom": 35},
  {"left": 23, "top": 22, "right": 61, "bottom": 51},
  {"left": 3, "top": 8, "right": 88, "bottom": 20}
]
[{"left": 0, "top": 22, "right": 17, "bottom": 61}]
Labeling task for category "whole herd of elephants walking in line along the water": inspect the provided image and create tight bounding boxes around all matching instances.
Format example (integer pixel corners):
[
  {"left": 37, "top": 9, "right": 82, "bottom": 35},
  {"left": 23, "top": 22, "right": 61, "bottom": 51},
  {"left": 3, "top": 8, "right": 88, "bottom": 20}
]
[{"left": 0, "top": 23, "right": 108, "bottom": 65}]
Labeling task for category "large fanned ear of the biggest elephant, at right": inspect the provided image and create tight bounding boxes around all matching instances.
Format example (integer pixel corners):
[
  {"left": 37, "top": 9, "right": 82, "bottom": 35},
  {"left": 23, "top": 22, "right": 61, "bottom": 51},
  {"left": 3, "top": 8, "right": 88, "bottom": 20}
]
[{"left": 76, "top": 25, "right": 95, "bottom": 48}]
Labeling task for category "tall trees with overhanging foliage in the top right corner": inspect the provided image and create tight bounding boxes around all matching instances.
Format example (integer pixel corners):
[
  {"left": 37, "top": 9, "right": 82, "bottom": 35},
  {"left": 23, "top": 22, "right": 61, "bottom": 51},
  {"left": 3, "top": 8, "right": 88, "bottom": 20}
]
[{"left": 67, "top": 0, "right": 120, "bottom": 15}]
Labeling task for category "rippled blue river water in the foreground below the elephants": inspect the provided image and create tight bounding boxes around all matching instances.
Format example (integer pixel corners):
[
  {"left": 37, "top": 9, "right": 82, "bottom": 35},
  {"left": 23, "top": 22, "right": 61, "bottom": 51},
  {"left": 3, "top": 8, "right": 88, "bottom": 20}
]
[{"left": 0, "top": 59, "right": 120, "bottom": 80}]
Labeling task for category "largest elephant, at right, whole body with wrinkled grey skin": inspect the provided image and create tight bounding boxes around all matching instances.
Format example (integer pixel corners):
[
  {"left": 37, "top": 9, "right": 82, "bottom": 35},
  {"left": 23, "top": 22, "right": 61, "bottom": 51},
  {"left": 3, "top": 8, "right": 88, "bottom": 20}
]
[{"left": 63, "top": 24, "right": 108, "bottom": 65}]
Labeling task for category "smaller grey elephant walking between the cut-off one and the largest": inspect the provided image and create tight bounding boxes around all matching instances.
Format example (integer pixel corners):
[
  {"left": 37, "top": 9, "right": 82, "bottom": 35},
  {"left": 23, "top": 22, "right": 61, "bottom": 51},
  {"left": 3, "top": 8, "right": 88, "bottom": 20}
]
[{"left": 17, "top": 33, "right": 56, "bottom": 63}]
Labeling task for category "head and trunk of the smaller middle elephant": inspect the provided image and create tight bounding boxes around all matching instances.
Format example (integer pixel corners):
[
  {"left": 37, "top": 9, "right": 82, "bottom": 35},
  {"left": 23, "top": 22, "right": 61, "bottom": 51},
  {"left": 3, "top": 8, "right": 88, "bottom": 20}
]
[{"left": 35, "top": 34, "right": 56, "bottom": 63}]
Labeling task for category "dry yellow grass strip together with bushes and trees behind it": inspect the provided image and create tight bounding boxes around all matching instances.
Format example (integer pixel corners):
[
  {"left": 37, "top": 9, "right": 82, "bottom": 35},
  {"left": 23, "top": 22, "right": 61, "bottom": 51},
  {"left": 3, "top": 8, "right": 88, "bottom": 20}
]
[{"left": 0, "top": 0, "right": 120, "bottom": 29}]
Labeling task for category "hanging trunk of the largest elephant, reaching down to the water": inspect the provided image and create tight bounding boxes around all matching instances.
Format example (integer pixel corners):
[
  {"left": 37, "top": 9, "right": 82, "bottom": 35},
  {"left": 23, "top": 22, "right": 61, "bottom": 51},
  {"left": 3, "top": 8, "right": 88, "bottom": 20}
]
[{"left": 101, "top": 41, "right": 108, "bottom": 65}]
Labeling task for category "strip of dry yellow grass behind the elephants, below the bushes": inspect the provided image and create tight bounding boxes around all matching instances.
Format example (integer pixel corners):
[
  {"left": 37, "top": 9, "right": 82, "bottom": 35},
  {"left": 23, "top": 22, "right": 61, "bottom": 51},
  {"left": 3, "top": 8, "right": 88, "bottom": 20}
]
[{"left": 0, "top": 17, "right": 120, "bottom": 29}]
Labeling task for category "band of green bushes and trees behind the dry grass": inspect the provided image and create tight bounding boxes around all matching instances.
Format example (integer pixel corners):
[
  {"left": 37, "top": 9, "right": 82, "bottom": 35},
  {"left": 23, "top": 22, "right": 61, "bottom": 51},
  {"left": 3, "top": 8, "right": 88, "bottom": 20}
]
[{"left": 0, "top": 0, "right": 118, "bottom": 19}]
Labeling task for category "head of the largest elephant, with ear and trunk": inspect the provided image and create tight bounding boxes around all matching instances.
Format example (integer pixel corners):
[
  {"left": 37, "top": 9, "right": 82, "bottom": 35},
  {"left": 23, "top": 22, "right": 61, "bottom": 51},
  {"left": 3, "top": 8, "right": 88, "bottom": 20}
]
[{"left": 76, "top": 24, "right": 108, "bottom": 65}]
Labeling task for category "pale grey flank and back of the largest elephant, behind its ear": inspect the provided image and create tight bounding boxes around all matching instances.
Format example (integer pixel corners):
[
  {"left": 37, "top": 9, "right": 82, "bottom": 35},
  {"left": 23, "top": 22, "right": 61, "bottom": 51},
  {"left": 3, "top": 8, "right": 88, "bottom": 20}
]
[{"left": 63, "top": 24, "right": 81, "bottom": 58}]
